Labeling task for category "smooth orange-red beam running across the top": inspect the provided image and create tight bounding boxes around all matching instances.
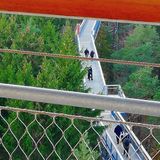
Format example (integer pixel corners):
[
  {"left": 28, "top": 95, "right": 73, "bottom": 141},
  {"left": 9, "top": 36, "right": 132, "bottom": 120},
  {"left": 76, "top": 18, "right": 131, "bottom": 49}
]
[{"left": 0, "top": 0, "right": 160, "bottom": 23}]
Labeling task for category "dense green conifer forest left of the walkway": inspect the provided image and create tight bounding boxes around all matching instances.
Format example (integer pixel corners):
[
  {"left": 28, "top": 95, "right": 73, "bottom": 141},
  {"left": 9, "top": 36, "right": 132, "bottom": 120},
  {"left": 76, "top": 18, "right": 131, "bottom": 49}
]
[{"left": 0, "top": 14, "right": 101, "bottom": 160}]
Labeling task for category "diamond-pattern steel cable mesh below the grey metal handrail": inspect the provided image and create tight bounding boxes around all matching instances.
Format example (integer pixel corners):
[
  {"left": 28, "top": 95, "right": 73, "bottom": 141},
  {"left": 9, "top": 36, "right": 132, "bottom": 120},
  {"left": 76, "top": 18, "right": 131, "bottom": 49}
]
[{"left": 0, "top": 107, "right": 160, "bottom": 160}]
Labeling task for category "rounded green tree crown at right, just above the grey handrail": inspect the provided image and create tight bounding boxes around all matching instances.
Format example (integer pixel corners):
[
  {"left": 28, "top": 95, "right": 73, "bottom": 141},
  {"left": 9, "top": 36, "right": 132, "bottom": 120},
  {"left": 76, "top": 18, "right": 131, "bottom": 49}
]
[{"left": 123, "top": 68, "right": 159, "bottom": 99}]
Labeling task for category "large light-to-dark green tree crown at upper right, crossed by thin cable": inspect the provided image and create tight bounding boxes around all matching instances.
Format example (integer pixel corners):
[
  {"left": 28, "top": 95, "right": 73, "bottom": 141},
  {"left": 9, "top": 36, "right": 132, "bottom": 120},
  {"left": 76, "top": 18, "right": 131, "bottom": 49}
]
[{"left": 112, "top": 25, "right": 159, "bottom": 84}]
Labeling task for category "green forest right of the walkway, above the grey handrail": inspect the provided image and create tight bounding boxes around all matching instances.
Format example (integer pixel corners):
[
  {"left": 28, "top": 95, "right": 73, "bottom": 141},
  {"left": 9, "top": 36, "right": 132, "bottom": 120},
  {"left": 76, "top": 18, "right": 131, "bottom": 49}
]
[{"left": 96, "top": 23, "right": 160, "bottom": 109}]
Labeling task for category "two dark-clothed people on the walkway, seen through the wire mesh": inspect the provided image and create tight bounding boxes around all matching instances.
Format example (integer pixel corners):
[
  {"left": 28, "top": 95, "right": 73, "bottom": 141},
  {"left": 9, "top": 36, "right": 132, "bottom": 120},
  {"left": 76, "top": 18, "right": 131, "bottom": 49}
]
[{"left": 114, "top": 125, "right": 131, "bottom": 157}]
